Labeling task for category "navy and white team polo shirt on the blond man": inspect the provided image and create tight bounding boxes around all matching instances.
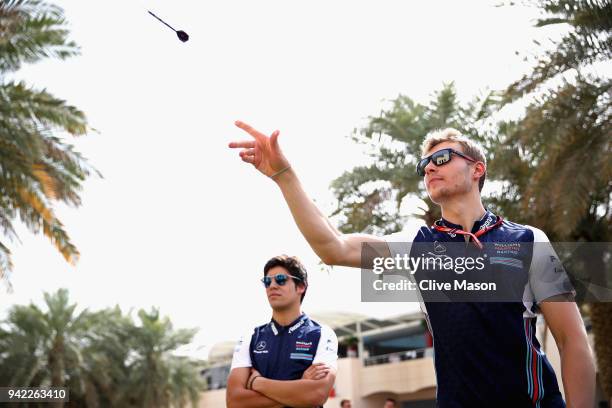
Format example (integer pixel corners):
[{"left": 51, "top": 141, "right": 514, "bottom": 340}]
[{"left": 385, "top": 211, "right": 573, "bottom": 408}]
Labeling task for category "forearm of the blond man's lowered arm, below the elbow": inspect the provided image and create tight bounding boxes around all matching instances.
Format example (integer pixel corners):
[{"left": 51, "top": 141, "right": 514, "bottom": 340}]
[{"left": 560, "top": 341, "right": 595, "bottom": 408}]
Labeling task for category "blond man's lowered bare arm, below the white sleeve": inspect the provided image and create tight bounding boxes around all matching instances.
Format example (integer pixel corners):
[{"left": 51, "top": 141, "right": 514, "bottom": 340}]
[{"left": 540, "top": 301, "right": 595, "bottom": 408}]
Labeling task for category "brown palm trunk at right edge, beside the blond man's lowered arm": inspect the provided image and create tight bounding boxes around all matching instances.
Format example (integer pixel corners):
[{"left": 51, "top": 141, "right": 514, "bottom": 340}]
[{"left": 590, "top": 302, "right": 612, "bottom": 400}]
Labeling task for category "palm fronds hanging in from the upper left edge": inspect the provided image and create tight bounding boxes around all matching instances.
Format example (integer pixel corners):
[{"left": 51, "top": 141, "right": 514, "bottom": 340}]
[{"left": 0, "top": 0, "right": 96, "bottom": 287}]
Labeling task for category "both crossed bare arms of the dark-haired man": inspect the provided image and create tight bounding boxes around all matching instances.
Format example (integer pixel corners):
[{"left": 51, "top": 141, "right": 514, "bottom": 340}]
[{"left": 226, "top": 363, "right": 336, "bottom": 408}]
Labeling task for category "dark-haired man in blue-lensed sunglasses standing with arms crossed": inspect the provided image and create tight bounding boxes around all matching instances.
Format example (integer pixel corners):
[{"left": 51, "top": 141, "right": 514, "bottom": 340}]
[{"left": 227, "top": 255, "right": 338, "bottom": 408}]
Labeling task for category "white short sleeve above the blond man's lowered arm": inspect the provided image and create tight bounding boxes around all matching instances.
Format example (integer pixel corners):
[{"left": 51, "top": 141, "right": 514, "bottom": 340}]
[{"left": 529, "top": 226, "right": 576, "bottom": 303}]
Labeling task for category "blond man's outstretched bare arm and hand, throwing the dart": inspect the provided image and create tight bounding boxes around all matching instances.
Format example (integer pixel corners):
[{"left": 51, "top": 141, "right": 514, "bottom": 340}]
[{"left": 229, "top": 121, "right": 387, "bottom": 267}]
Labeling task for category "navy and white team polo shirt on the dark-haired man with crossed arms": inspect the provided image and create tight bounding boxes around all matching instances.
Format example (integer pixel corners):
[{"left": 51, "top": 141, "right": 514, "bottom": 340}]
[{"left": 231, "top": 314, "right": 338, "bottom": 380}]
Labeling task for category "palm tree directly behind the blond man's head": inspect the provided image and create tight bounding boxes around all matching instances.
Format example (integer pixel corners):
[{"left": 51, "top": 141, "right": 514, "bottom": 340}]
[{"left": 331, "top": 83, "right": 496, "bottom": 234}]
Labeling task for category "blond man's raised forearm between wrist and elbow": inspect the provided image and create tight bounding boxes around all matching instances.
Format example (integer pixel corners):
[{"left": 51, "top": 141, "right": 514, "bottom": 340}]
[{"left": 275, "top": 169, "right": 342, "bottom": 265}]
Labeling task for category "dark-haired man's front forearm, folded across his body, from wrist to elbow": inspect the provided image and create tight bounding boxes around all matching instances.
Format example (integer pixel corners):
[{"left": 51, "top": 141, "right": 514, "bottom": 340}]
[{"left": 253, "top": 377, "right": 327, "bottom": 407}]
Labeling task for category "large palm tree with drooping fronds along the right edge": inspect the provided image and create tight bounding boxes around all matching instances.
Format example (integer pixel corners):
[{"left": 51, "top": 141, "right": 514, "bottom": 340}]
[{"left": 497, "top": 0, "right": 612, "bottom": 400}]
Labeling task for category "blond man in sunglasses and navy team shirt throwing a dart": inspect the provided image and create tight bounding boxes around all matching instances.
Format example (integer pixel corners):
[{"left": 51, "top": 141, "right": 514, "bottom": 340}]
[{"left": 229, "top": 122, "right": 595, "bottom": 408}]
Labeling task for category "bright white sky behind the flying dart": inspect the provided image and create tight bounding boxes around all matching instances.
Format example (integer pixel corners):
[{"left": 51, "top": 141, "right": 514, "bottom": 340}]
[{"left": 0, "top": 0, "right": 564, "bottom": 355}]
